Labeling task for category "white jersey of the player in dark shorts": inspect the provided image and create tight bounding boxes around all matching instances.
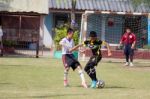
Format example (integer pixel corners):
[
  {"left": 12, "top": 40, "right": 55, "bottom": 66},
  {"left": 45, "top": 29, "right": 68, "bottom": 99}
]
[{"left": 59, "top": 38, "right": 74, "bottom": 54}]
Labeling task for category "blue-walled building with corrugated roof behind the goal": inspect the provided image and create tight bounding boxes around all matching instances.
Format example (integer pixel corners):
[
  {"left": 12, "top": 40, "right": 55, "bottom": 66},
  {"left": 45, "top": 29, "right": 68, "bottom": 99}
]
[{"left": 44, "top": 0, "right": 150, "bottom": 47}]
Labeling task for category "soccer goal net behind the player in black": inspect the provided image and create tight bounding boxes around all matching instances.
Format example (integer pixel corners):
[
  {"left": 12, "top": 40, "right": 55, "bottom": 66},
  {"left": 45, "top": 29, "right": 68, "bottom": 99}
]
[{"left": 79, "top": 14, "right": 150, "bottom": 59}]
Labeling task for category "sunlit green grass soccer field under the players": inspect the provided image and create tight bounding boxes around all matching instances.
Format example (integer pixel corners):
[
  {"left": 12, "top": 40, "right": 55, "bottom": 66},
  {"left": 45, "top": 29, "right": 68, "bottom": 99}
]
[{"left": 0, "top": 58, "right": 150, "bottom": 99}]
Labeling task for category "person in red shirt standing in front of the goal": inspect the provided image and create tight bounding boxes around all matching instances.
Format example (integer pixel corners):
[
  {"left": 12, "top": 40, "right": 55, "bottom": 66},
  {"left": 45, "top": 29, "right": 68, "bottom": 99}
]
[{"left": 120, "top": 28, "right": 136, "bottom": 66}]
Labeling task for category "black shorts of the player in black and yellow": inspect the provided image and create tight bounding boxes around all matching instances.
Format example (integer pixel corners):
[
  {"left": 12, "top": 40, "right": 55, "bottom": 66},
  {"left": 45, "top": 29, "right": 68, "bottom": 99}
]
[{"left": 86, "top": 55, "right": 102, "bottom": 67}]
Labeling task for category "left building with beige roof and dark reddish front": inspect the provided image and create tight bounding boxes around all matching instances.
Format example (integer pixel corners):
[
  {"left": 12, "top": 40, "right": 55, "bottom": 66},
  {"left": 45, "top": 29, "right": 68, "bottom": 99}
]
[{"left": 0, "top": 0, "right": 49, "bottom": 57}]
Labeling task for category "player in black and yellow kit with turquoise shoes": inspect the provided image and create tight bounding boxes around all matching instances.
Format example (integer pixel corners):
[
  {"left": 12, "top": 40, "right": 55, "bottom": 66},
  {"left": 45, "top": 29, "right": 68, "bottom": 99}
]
[{"left": 83, "top": 31, "right": 112, "bottom": 88}]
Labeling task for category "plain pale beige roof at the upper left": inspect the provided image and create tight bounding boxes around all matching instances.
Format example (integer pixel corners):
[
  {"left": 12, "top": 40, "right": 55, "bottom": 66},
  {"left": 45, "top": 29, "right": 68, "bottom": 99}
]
[{"left": 0, "top": 0, "right": 49, "bottom": 14}]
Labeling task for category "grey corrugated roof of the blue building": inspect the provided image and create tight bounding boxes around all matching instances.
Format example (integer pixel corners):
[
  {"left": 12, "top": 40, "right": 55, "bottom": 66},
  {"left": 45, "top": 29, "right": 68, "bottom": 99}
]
[{"left": 49, "top": 0, "right": 150, "bottom": 13}]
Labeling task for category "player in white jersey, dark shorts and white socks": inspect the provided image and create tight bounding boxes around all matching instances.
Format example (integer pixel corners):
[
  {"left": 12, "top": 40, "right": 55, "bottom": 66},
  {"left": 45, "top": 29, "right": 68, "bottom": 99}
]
[{"left": 59, "top": 28, "right": 87, "bottom": 88}]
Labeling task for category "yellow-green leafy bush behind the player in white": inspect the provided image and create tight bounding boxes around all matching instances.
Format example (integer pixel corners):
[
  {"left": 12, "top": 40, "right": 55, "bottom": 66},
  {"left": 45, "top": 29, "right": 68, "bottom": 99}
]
[{"left": 54, "top": 25, "right": 79, "bottom": 50}]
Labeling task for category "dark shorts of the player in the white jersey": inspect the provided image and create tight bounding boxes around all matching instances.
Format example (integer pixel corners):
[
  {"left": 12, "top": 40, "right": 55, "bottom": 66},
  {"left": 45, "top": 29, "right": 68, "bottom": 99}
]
[{"left": 62, "top": 54, "right": 80, "bottom": 70}]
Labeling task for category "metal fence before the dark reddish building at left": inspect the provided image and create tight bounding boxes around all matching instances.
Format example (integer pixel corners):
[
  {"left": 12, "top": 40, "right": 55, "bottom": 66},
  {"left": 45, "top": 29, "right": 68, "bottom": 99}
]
[{"left": 1, "top": 15, "right": 42, "bottom": 57}]
